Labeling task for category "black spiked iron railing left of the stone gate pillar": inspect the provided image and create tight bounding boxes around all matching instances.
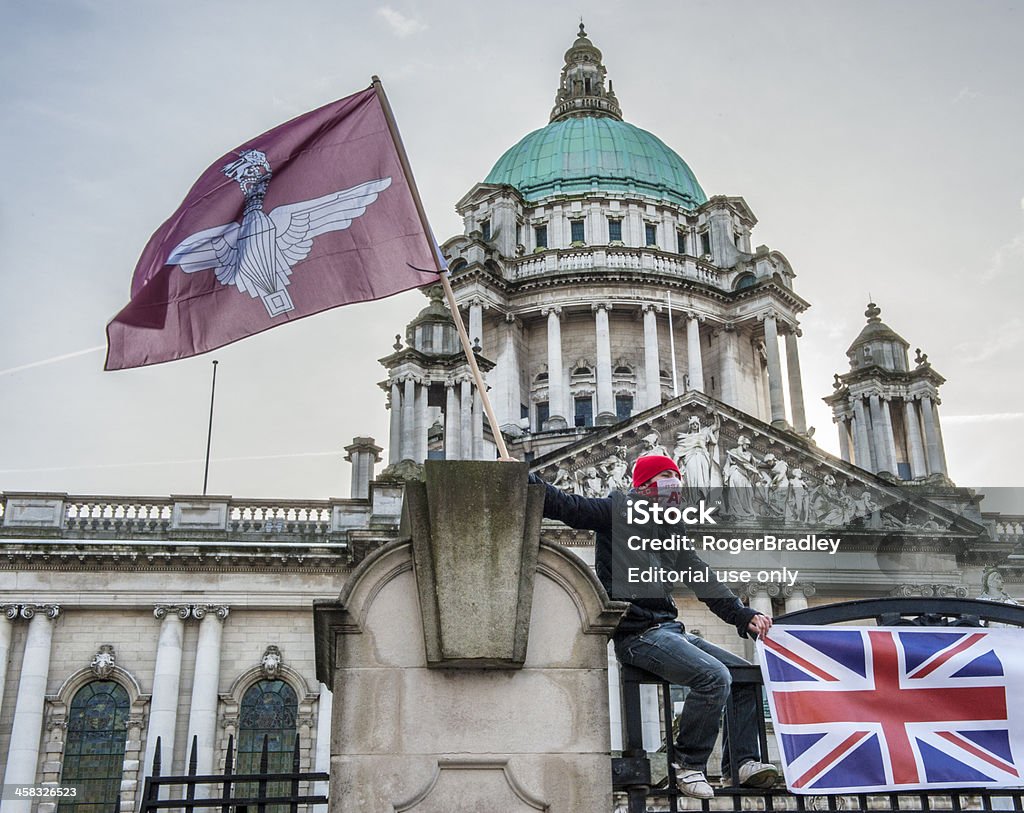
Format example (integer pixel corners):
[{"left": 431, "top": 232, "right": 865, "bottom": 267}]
[{"left": 139, "top": 736, "right": 329, "bottom": 813}]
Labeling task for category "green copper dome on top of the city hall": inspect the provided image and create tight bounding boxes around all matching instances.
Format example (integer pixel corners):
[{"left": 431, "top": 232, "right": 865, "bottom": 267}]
[{"left": 484, "top": 116, "right": 708, "bottom": 209}]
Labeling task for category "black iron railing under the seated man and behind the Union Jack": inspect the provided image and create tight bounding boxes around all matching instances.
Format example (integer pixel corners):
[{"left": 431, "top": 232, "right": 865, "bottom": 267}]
[{"left": 611, "top": 598, "right": 1024, "bottom": 813}]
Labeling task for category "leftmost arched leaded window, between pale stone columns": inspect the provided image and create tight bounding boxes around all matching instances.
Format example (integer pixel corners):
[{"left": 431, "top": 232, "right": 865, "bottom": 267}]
[{"left": 57, "top": 680, "right": 131, "bottom": 813}]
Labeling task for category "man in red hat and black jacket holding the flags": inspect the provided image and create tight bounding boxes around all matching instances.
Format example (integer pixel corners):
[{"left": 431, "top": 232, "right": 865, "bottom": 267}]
[{"left": 530, "top": 455, "right": 778, "bottom": 799}]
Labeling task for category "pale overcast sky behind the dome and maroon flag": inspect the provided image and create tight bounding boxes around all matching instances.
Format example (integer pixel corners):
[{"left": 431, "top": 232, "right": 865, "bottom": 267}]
[{"left": 0, "top": 0, "right": 1024, "bottom": 499}]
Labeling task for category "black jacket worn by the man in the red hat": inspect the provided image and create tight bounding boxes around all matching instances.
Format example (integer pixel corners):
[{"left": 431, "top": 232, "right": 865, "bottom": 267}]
[{"left": 529, "top": 474, "right": 760, "bottom": 639}]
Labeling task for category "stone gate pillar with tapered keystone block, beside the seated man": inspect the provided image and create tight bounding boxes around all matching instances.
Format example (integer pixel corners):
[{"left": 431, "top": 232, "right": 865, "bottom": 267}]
[{"left": 314, "top": 463, "right": 626, "bottom": 813}]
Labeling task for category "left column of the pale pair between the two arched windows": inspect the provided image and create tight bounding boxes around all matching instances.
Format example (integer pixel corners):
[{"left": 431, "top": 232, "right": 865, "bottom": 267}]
[{"left": 142, "top": 604, "right": 191, "bottom": 776}]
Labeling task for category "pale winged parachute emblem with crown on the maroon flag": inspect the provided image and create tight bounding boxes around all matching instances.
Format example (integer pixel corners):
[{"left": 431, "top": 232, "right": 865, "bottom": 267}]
[{"left": 167, "top": 149, "right": 391, "bottom": 318}]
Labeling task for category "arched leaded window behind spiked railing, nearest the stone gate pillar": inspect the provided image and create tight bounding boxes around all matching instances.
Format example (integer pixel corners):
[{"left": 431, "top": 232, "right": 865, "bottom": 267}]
[{"left": 236, "top": 680, "right": 299, "bottom": 813}]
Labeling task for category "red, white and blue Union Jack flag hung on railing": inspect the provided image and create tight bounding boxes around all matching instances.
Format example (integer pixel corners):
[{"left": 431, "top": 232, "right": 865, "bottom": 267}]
[{"left": 758, "top": 625, "right": 1024, "bottom": 794}]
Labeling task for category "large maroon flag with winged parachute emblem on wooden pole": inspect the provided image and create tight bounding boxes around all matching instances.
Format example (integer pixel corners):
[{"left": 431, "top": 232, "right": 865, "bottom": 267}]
[{"left": 105, "top": 86, "right": 438, "bottom": 370}]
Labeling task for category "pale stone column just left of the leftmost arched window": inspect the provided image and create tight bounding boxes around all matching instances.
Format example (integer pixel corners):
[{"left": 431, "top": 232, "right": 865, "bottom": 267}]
[{"left": 3, "top": 604, "right": 60, "bottom": 813}]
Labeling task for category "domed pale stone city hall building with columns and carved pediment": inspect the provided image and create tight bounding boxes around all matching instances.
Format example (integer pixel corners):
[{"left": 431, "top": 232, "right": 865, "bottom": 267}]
[{"left": 0, "top": 26, "right": 1022, "bottom": 813}]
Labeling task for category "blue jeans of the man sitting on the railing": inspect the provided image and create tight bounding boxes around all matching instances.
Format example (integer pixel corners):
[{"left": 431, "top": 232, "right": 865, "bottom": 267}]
[{"left": 615, "top": 622, "right": 760, "bottom": 776}]
